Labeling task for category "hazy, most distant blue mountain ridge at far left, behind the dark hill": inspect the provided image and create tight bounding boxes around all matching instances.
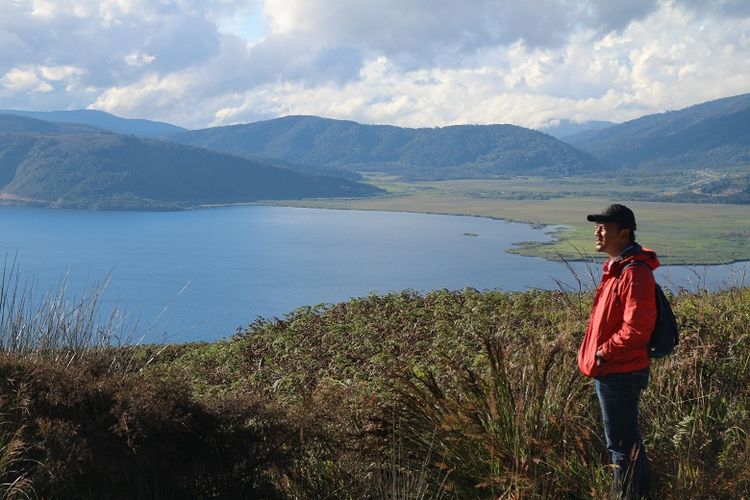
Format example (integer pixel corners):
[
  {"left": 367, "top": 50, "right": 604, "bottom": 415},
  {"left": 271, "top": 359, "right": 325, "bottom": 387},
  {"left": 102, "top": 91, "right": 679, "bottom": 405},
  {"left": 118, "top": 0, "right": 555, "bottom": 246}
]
[{"left": 0, "top": 109, "right": 186, "bottom": 138}]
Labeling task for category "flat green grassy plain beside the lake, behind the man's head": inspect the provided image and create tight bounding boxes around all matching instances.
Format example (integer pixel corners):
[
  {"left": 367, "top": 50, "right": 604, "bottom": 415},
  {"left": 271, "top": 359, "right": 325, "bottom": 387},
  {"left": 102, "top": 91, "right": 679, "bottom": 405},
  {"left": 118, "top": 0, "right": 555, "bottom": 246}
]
[{"left": 266, "top": 176, "right": 750, "bottom": 265}]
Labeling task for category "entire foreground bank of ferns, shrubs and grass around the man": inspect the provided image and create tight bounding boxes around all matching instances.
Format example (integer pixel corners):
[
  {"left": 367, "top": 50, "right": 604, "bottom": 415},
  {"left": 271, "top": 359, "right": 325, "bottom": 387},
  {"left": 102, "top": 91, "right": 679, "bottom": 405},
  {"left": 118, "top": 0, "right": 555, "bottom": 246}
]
[{"left": 0, "top": 276, "right": 750, "bottom": 499}]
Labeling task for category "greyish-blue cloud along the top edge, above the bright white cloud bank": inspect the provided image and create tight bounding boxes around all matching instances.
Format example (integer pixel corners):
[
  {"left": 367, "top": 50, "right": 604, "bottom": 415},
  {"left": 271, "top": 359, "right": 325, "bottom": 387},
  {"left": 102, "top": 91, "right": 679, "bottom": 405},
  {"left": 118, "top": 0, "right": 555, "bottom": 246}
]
[{"left": 263, "top": 0, "right": 657, "bottom": 68}]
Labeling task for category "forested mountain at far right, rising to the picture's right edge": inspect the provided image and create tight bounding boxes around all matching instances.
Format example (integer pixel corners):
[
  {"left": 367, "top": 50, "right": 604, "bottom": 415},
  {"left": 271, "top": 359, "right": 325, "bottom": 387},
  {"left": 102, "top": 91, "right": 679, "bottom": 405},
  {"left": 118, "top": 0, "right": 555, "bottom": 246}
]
[{"left": 565, "top": 94, "right": 750, "bottom": 170}]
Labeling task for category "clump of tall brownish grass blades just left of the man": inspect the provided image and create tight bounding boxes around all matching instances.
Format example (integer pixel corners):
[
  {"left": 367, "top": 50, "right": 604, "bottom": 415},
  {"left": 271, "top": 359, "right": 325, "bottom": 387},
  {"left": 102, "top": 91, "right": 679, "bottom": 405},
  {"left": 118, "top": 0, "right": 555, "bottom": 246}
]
[{"left": 382, "top": 293, "right": 604, "bottom": 498}]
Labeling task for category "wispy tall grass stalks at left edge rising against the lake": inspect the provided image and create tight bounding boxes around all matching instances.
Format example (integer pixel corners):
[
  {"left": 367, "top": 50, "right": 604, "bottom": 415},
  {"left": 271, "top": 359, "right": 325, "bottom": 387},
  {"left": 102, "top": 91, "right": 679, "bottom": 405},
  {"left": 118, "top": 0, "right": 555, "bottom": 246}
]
[{"left": 0, "top": 257, "right": 141, "bottom": 498}]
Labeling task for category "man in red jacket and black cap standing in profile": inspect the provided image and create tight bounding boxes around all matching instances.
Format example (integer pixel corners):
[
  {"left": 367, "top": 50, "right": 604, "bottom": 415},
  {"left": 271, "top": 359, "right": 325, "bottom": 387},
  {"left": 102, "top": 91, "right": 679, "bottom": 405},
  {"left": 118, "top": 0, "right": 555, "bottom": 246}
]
[{"left": 578, "top": 204, "right": 659, "bottom": 498}]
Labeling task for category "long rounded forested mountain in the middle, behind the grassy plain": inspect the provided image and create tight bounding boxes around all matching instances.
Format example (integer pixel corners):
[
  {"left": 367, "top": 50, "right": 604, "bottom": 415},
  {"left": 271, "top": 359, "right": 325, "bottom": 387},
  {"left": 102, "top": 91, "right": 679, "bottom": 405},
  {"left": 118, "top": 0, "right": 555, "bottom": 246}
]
[{"left": 169, "top": 116, "right": 599, "bottom": 179}]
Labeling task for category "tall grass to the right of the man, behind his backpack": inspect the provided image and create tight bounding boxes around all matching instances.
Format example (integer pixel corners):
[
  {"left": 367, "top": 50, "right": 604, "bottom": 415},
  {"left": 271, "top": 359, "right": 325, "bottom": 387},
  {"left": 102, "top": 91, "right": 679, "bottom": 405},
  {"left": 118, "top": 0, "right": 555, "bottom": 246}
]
[{"left": 643, "top": 288, "right": 750, "bottom": 498}]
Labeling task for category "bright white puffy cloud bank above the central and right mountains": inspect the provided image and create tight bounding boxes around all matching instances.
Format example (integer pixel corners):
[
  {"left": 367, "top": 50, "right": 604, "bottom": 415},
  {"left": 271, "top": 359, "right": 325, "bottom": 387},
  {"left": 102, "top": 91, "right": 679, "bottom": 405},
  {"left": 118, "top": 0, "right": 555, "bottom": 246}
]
[{"left": 166, "top": 0, "right": 750, "bottom": 127}]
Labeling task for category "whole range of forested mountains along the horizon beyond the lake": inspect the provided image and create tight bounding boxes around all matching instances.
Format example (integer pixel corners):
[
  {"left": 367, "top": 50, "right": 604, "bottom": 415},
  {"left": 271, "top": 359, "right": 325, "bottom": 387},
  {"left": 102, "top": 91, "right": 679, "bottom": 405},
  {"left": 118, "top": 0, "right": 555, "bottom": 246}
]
[{"left": 0, "top": 94, "right": 750, "bottom": 211}]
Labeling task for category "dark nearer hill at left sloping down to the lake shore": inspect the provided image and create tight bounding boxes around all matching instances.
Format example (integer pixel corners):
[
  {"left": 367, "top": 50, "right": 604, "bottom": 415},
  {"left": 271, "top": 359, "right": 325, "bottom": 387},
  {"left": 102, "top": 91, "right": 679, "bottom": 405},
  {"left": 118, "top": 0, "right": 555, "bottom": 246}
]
[{"left": 0, "top": 115, "right": 380, "bottom": 209}]
